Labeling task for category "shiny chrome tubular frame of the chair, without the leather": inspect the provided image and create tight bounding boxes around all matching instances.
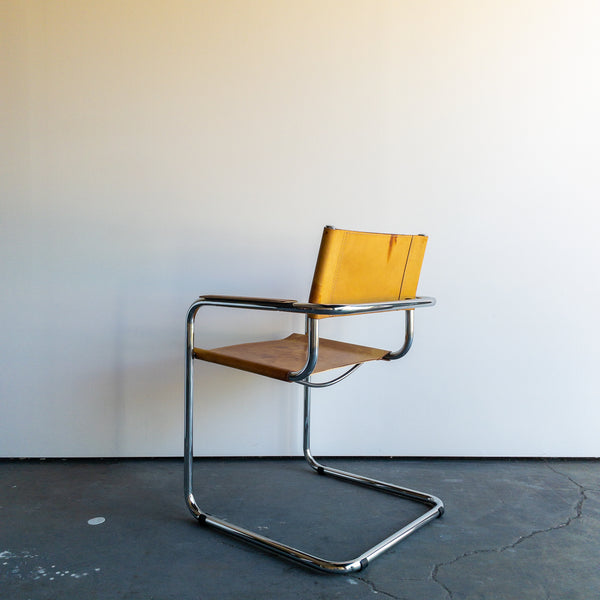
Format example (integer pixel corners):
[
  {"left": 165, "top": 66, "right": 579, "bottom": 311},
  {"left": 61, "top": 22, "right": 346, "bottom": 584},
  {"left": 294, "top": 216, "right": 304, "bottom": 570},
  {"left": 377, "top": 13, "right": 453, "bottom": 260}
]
[{"left": 184, "top": 296, "right": 444, "bottom": 574}]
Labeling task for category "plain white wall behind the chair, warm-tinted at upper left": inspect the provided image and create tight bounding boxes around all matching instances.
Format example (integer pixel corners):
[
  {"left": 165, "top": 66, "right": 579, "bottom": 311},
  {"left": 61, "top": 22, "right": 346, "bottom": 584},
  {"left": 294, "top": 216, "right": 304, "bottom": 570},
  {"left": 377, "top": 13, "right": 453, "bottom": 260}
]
[{"left": 0, "top": 0, "right": 600, "bottom": 456}]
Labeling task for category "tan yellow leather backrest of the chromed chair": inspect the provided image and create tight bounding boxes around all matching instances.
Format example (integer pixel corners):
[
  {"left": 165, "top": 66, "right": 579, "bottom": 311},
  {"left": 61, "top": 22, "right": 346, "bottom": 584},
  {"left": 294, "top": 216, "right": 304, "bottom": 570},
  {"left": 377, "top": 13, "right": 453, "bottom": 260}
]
[{"left": 309, "top": 227, "right": 427, "bottom": 318}]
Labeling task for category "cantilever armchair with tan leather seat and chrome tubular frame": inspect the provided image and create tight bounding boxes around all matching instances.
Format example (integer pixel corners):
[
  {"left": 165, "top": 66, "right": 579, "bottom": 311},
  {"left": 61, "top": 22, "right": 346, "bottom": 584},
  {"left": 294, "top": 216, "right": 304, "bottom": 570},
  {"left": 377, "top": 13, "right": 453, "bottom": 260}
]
[{"left": 184, "top": 227, "right": 444, "bottom": 573}]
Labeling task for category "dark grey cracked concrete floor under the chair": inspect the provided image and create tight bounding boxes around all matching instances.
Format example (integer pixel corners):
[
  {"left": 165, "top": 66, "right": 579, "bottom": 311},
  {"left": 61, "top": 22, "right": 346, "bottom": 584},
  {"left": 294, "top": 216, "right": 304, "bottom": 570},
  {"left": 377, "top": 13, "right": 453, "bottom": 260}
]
[{"left": 0, "top": 459, "right": 600, "bottom": 600}]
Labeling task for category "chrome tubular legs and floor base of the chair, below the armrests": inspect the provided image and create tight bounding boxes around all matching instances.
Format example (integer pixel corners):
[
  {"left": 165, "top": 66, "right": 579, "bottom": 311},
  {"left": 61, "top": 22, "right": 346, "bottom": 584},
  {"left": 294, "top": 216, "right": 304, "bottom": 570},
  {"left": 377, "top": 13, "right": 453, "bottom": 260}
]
[{"left": 184, "top": 301, "right": 444, "bottom": 574}]
